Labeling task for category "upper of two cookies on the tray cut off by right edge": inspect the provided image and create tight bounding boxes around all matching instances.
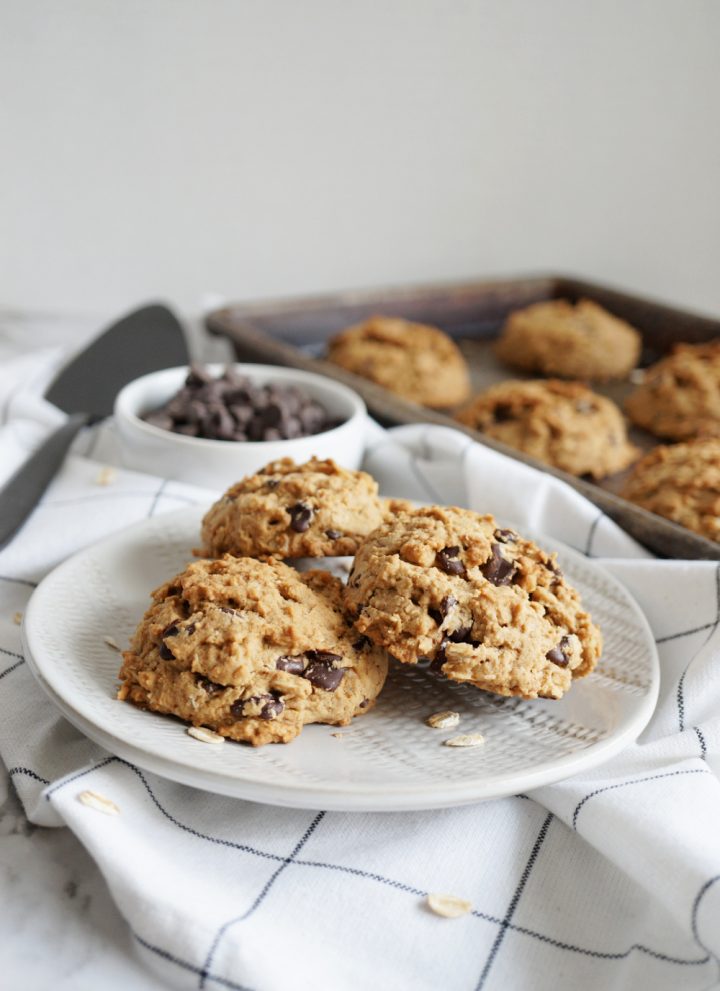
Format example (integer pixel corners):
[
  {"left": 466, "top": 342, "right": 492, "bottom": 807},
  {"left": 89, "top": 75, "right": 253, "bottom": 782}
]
[{"left": 625, "top": 340, "right": 720, "bottom": 440}]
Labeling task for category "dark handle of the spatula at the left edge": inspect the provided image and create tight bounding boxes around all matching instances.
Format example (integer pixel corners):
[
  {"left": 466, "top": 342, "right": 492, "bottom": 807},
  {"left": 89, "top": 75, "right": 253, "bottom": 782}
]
[{"left": 0, "top": 413, "right": 90, "bottom": 550}]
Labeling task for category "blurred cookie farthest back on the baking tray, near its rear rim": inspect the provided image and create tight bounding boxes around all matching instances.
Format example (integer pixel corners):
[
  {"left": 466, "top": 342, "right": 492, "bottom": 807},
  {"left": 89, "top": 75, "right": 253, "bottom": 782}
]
[{"left": 496, "top": 299, "right": 641, "bottom": 382}]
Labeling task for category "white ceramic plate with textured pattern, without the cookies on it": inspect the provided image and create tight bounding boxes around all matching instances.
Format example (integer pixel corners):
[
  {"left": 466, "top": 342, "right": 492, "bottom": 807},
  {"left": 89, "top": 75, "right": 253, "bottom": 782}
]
[{"left": 23, "top": 508, "right": 659, "bottom": 811}]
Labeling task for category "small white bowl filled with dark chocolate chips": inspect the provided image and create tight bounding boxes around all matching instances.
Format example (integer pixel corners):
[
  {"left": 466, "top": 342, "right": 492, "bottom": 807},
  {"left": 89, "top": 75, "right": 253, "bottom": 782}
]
[{"left": 115, "top": 364, "right": 367, "bottom": 489}]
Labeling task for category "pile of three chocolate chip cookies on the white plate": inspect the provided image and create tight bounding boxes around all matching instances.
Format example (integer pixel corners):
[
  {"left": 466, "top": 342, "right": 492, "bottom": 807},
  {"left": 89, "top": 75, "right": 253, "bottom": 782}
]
[{"left": 119, "top": 459, "right": 601, "bottom": 746}]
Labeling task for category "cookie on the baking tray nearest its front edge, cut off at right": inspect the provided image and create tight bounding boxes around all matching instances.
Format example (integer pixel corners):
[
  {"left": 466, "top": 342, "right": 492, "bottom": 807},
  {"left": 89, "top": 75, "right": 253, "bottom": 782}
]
[{"left": 622, "top": 437, "right": 720, "bottom": 541}]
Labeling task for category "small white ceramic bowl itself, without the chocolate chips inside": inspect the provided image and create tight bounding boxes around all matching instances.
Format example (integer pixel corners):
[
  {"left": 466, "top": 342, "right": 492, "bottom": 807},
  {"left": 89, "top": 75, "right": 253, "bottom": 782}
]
[{"left": 115, "top": 364, "right": 367, "bottom": 489}]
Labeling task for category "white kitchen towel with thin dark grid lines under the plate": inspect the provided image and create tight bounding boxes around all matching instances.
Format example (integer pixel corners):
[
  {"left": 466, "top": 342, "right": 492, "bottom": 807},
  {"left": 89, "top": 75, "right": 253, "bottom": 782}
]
[{"left": 0, "top": 344, "right": 720, "bottom": 991}]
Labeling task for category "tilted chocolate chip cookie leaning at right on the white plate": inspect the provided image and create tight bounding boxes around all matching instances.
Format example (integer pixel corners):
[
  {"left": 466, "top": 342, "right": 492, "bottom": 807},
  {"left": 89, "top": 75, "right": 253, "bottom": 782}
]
[{"left": 344, "top": 506, "right": 602, "bottom": 699}]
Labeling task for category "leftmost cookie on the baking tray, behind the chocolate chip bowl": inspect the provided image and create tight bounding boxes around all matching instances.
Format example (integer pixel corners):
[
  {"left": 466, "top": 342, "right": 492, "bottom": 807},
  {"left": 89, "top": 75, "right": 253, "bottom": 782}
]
[{"left": 328, "top": 316, "right": 470, "bottom": 409}]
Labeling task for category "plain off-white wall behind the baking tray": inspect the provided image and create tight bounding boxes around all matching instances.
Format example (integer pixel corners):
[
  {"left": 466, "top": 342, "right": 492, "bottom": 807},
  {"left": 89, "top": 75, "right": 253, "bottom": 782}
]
[{"left": 0, "top": 0, "right": 720, "bottom": 315}]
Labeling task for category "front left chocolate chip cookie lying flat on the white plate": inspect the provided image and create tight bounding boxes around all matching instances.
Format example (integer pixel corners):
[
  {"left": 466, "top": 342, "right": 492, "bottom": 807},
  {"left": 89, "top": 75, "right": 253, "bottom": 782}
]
[{"left": 118, "top": 557, "right": 387, "bottom": 746}]
